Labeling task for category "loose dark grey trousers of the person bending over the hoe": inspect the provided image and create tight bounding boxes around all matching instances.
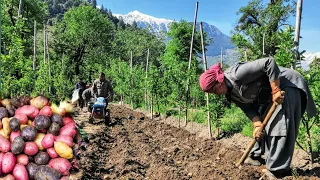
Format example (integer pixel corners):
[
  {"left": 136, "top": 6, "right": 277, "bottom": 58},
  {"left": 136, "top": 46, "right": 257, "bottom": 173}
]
[{"left": 251, "top": 88, "right": 306, "bottom": 171}]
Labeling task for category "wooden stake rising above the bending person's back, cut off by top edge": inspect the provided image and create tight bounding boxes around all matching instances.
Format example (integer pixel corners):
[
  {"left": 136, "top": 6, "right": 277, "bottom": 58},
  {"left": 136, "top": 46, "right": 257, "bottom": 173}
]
[{"left": 291, "top": 0, "right": 302, "bottom": 69}]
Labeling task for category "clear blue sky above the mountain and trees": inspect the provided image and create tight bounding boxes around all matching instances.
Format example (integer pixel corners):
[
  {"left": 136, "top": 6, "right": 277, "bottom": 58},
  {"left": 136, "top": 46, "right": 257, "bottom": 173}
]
[{"left": 97, "top": 0, "right": 320, "bottom": 52}]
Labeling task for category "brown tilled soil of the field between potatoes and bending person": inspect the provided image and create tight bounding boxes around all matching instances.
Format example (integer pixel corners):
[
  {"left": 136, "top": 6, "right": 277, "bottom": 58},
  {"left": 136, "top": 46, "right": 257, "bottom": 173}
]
[{"left": 70, "top": 105, "right": 320, "bottom": 180}]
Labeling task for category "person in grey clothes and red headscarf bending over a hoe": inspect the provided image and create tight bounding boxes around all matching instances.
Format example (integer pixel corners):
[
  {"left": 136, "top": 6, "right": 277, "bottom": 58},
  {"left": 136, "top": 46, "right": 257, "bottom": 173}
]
[{"left": 199, "top": 57, "right": 317, "bottom": 179}]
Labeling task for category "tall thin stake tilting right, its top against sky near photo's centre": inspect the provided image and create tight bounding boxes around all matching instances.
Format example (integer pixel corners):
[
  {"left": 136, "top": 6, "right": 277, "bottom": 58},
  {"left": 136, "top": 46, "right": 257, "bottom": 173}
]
[{"left": 184, "top": 2, "right": 199, "bottom": 125}]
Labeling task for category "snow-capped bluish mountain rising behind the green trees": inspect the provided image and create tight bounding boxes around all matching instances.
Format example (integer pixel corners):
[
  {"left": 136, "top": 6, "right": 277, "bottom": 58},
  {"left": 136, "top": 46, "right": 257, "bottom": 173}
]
[{"left": 114, "top": 11, "right": 235, "bottom": 56}]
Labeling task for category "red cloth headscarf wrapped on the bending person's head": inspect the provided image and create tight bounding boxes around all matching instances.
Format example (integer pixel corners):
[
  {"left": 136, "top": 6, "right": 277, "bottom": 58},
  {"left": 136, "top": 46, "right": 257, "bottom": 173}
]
[{"left": 199, "top": 63, "right": 224, "bottom": 92}]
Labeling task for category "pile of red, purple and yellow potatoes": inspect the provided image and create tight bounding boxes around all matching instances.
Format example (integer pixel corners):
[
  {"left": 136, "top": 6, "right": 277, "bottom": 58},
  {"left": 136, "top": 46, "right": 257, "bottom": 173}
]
[{"left": 0, "top": 96, "right": 78, "bottom": 180}]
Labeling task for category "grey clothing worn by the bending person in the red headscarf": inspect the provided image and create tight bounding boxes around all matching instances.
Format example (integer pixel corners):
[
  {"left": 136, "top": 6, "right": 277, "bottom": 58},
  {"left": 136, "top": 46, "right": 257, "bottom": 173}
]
[{"left": 224, "top": 57, "right": 317, "bottom": 171}]
